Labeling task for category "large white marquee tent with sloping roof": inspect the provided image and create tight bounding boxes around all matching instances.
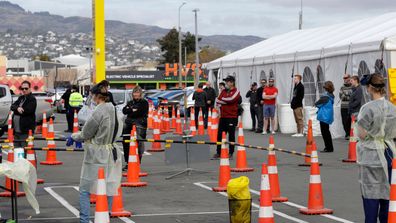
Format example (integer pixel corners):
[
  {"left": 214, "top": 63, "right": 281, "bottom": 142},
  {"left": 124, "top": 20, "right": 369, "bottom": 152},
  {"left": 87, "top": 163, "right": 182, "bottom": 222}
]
[{"left": 206, "top": 13, "right": 396, "bottom": 137}]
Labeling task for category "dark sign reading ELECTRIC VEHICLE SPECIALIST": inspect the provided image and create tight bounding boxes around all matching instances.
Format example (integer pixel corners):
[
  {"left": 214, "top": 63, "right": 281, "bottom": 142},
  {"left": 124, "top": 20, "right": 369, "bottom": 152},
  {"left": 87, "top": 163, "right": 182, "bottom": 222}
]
[{"left": 106, "top": 71, "right": 164, "bottom": 81}]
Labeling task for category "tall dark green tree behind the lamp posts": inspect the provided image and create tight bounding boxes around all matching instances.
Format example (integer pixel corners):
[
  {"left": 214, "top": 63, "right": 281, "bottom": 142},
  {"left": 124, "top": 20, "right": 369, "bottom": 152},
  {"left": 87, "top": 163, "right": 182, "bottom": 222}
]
[{"left": 157, "top": 28, "right": 202, "bottom": 63}]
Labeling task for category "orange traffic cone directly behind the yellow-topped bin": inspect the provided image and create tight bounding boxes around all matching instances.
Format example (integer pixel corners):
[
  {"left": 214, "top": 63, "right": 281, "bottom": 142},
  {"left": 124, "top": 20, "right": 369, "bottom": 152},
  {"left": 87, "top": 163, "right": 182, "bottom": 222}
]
[{"left": 212, "top": 132, "right": 231, "bottom": 192}]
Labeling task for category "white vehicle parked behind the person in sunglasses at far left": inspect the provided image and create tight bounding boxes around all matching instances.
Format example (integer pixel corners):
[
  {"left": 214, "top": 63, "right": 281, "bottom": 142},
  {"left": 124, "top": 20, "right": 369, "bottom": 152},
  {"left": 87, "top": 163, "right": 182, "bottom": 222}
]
[{"left": 0, "top": 84, "right": 55, "bottom": 136}]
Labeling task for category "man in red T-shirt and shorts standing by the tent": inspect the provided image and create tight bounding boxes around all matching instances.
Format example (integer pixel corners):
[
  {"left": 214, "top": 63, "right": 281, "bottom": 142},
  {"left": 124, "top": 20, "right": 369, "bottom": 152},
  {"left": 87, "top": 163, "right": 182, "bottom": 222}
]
[{"left": 262, "top": 79, "right": 278, "bottom": 135}]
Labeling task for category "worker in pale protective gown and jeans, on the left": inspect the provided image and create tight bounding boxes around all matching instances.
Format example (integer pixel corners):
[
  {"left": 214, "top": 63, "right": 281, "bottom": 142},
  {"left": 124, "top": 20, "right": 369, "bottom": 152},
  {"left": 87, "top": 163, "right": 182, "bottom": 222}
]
[{"left": 71, "top": 84, "right": 123, "bottom": 223}]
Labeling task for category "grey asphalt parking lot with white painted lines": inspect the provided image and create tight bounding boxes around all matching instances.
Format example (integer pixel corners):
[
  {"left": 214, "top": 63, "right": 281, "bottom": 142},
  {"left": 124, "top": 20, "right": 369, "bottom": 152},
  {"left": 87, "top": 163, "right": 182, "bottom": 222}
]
[{"left": 0, "top": 114, "right": 364, "bottom": 223}]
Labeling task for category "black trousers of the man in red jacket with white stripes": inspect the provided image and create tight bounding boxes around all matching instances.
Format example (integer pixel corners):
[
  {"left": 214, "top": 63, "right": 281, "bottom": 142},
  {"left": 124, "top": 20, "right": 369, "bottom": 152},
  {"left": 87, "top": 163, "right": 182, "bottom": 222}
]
[{"left": 217, "top": 118, "right": 238, "bottom": 155}]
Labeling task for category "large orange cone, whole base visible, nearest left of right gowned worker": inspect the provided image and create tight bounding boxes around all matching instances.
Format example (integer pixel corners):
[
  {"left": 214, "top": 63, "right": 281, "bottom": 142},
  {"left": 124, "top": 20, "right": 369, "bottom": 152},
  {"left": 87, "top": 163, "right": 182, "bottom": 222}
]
[{"left": 300, "top": 142, "right": 333, "bottom": 215}]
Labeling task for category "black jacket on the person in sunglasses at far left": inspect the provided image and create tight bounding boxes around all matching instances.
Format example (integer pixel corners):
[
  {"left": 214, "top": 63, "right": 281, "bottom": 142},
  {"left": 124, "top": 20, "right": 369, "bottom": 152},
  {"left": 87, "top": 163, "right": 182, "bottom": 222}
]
[{"left": 10, "top": 94, "right": 37, "bottom": 134}]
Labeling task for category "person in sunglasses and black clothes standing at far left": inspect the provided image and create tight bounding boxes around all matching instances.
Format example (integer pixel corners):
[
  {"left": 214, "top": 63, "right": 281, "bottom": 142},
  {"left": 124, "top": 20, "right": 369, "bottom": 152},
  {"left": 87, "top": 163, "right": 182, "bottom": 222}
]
[{"left": 10, "top": 81, "right": 37, "bottom": 148}]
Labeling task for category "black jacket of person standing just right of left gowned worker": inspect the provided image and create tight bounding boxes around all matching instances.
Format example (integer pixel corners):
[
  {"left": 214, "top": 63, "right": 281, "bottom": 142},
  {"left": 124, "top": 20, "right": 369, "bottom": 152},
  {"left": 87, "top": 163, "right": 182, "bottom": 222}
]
[{"left": 122, "top": 98, "right": 149, "bottom": 130}]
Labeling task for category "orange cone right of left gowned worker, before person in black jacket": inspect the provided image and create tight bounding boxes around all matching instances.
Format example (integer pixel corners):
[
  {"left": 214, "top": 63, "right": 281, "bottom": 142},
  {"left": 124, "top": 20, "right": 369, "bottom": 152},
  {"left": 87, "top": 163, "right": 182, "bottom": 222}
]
[{"left": 121, "top": 126, "right": 147, "bottom": 187}]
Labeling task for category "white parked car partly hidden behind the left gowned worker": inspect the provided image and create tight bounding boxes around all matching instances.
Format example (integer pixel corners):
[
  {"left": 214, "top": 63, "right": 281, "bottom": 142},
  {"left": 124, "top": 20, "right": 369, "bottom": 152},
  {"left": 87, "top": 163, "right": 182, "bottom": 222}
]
[{"left": 77, "top": 89, "right": 132, "bottom": 126}]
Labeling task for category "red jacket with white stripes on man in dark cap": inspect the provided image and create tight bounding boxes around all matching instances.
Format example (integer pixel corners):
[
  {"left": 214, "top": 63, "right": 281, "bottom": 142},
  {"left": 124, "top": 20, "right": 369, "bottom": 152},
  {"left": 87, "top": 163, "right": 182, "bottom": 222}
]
[{"left": 216, "top": 88, "right": 241, "bottom": 118}]
